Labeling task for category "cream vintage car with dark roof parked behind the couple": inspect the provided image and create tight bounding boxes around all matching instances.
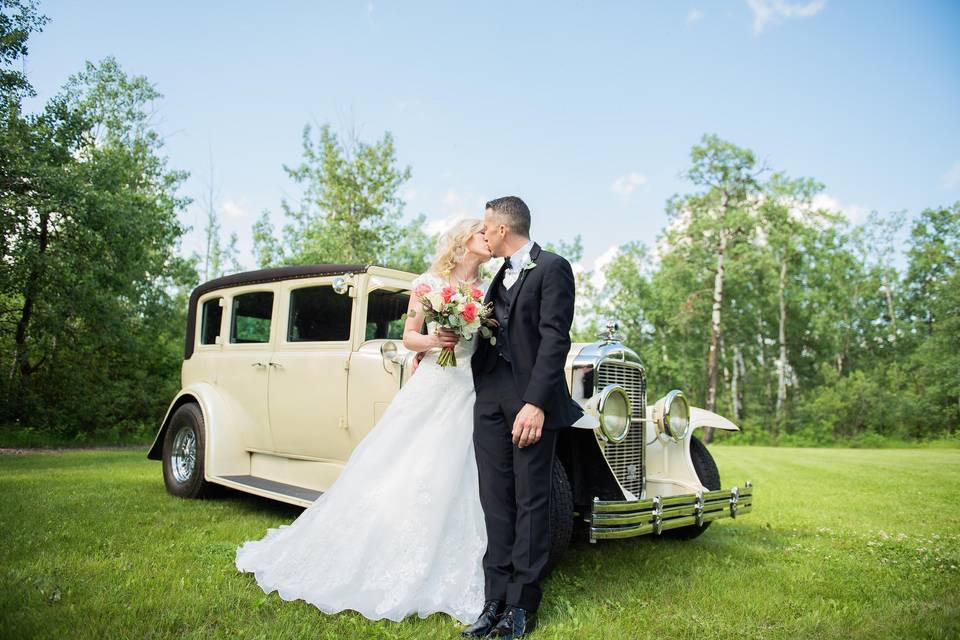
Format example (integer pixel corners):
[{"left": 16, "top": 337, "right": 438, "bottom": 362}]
[{"left": 147, "top": 264, "right": 753, "bottom": 553}]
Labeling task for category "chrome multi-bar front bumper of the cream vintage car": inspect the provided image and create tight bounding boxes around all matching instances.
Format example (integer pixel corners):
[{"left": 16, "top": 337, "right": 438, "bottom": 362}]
[{"left": 590, "top": 480, "right": 753, "bottom": 542}]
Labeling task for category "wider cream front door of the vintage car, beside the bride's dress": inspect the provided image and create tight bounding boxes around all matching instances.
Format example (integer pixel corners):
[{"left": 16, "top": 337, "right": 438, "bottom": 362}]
[{"left": 268, "top": 278, "right": 355, "bottom": 462}]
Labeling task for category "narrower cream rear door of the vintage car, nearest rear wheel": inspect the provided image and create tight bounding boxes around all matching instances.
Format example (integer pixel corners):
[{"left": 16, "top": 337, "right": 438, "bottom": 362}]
[{"left": 217, "top": 285, "right": 277, "bottom": 451}]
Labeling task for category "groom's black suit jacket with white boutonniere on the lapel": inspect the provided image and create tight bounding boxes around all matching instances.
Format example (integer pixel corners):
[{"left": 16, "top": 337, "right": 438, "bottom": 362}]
[{"left": 471, "top": 243, "right": 583, "bottom": 429}]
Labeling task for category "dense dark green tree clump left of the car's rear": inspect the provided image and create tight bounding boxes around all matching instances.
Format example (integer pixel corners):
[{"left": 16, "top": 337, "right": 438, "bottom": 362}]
[{"left": 0, "top": 58, "right": 196, "bottom": 430}]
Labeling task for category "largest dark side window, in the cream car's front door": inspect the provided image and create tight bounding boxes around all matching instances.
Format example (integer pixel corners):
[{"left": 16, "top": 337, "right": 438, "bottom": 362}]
[{"left": 287, "top": 285, "right": 353, "bottom": 342}]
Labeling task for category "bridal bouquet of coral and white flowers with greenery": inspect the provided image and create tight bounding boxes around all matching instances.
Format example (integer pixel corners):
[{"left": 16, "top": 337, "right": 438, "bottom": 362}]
[{"left": 413, "top": 282, "right": 497, "bottom": 367}]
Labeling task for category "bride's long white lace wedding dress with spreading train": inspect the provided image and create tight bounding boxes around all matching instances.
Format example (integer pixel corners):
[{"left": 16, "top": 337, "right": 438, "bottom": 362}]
[{"left": 236, "top": 273, "right": 487, "bottom": 624}]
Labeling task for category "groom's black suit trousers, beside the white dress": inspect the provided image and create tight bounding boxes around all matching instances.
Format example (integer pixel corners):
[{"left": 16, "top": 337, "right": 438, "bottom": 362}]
[{"left": 473, "top": 357, "right": 557, "bottom": 611}]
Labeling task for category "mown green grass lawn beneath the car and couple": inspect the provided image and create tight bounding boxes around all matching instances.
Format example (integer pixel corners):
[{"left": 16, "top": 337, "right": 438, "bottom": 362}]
[{"left": 0, "top": 446, "right": 960, "bottom": 640}]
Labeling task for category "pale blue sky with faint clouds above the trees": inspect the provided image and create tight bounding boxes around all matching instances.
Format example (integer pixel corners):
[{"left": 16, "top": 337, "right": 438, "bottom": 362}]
[{"left": 18, "top": 0, "right": 960, "bottom": 276}]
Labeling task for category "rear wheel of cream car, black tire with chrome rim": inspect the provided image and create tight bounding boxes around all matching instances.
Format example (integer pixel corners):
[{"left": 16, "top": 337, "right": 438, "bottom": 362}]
[{"left": 163, "top": 402, "right": 211, "bottom": 498}]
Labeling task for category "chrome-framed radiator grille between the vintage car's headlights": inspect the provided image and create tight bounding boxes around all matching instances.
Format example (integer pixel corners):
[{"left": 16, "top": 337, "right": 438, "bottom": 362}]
[{"left": 595, "top": 360, "right": 647, "bottom": 498}]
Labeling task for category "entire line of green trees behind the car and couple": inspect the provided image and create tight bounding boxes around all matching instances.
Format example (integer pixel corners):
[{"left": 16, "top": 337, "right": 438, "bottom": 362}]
[{"left": 0, "top": 0, "right": 960, "bottom": 444}]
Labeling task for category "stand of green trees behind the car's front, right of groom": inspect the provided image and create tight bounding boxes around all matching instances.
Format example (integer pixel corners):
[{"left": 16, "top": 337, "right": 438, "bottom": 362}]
[{"left": 590, "top": 131, "right": 960, "bottom": 446}]
